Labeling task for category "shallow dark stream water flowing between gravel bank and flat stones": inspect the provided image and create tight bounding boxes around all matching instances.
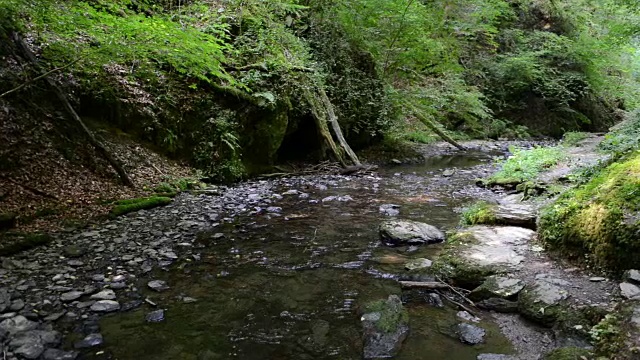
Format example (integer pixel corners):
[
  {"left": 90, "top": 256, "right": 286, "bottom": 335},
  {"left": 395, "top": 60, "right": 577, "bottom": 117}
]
[{"left": 94, "top": 152, "right": 512, "bottom": 360}]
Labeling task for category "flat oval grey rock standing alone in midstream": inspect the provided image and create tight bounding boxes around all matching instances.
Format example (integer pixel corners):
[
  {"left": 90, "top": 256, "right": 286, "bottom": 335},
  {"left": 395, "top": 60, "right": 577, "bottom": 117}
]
[{"left": 379, "top": 220, "right": 445, "bottom": 246}]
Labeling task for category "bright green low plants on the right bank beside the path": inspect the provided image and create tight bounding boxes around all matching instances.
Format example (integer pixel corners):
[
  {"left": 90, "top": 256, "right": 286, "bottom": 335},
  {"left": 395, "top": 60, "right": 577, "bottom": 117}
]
[{"left": 486, "top": 146, "right": 564, "bottom": 186}]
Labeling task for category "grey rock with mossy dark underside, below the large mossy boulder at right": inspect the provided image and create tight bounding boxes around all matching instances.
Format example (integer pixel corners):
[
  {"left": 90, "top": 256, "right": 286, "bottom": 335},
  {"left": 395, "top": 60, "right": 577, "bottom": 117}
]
[{"left": 518, "top": 279, "right": 569, "bottom": 326}]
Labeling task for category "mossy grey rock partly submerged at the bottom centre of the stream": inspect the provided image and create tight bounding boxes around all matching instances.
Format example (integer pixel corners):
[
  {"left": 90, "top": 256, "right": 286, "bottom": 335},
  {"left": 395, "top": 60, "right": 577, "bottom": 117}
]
[{"left": 361, "top": 295, "right": 409, "bottom": 359}]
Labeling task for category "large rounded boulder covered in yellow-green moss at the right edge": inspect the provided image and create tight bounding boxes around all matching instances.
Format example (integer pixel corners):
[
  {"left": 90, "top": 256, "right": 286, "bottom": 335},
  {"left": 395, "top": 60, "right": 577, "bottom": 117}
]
[{"left": 538, "top": 153, "right": 640, "bottom": 270}]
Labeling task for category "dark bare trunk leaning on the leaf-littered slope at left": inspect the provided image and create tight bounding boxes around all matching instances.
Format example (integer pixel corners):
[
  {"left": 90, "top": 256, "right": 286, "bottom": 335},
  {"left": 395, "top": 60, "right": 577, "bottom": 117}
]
[{"left": 12, "top": 32, "right": 133, "bottom": 187}]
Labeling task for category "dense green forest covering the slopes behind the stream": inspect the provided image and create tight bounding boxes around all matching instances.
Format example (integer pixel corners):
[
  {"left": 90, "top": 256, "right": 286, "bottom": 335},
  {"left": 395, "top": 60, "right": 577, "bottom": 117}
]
[{"left": 0, "top": 0, "right": 640, "bottom": 181}]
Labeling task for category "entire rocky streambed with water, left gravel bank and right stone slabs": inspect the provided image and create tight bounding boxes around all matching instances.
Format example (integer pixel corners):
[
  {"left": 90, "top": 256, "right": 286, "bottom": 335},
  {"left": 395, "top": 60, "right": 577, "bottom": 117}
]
[{"left": 0, "top": 143, "right": 640, "bottom": 360}]
